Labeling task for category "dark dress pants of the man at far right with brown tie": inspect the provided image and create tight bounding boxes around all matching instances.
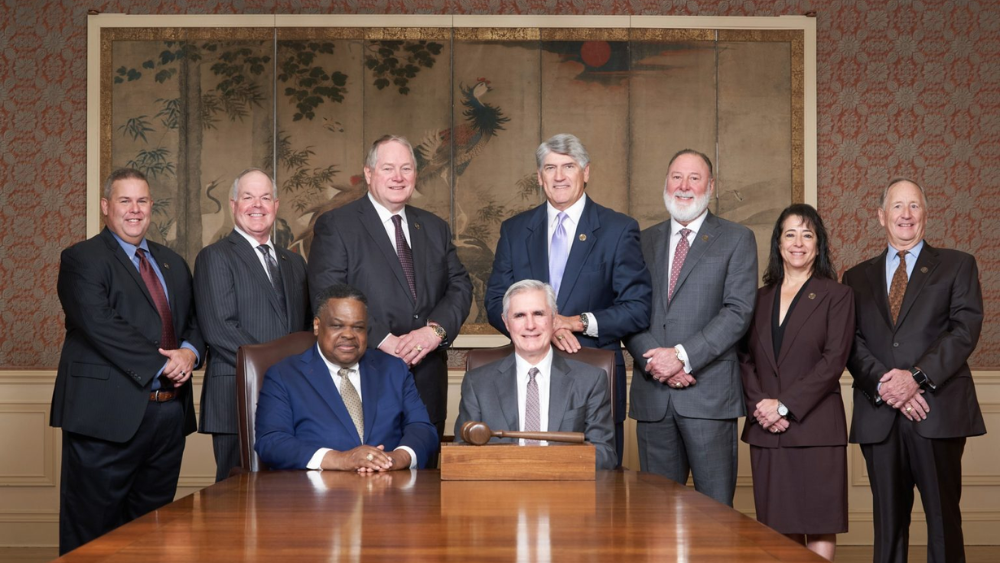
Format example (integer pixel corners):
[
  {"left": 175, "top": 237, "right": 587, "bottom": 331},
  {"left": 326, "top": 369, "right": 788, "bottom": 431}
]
[{"left": 861, "top": 413, "right": 965, "bottom": 563}]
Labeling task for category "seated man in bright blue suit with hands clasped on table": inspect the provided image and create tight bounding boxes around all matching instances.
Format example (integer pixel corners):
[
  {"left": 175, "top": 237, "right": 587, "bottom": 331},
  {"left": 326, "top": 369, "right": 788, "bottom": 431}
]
[{"left": 255, "top": 284, "right": 438, "bottom": 473}]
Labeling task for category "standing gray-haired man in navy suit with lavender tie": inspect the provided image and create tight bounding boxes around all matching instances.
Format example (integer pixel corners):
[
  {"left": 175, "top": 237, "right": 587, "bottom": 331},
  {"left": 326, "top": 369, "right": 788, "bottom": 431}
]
[{"left": 486, "top": 134, "right": 652, "bottom": 465}]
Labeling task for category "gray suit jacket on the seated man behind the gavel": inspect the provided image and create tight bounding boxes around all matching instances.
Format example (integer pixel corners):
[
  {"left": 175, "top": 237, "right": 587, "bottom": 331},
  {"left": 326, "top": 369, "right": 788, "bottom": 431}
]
[{"left": 455, "top": 354, "right": 618, "bottom": 469}]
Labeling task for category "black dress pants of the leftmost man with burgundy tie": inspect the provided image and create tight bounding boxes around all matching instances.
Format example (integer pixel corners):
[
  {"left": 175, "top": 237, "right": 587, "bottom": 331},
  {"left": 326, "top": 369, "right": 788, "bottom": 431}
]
[{"left": 59, "top": 399, "right": 185, "bottom": 555}]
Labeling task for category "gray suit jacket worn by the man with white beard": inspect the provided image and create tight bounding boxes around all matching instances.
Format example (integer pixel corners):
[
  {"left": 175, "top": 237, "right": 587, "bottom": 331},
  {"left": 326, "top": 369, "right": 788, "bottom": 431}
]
[{"left": 625, "top": 212, "right": 757, "bottom": 422}]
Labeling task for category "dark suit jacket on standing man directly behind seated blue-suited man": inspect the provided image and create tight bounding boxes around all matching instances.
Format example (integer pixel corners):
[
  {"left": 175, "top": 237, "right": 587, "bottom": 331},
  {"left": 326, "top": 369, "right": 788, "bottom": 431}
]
[{"left": 309, "top": 196, "right": 472, "bottom": 423}]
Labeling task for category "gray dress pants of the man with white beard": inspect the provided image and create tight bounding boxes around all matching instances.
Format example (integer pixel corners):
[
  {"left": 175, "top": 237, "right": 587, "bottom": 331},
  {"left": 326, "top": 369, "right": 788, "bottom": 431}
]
[{"left": 636, "top": 396, "right": 737, "bottom": 506}]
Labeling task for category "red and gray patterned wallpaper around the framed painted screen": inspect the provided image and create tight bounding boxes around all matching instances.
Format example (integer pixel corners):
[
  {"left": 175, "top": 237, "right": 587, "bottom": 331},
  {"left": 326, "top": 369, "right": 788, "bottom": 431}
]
[{"left": 0, "top": 0, "right": 1000, "bottom": 369}]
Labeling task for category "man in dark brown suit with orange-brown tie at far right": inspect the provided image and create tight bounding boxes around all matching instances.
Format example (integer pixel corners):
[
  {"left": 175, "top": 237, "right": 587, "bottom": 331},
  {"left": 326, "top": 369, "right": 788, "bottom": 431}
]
[{"left": 844, "top": 179, "right": 986, "bottom": 563}]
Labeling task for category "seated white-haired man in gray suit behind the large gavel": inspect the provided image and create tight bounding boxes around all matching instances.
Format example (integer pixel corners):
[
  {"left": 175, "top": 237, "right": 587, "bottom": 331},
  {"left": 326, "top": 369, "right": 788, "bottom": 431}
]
[{"left": 455, "top": 280, "right": 618, "bottom": 469}]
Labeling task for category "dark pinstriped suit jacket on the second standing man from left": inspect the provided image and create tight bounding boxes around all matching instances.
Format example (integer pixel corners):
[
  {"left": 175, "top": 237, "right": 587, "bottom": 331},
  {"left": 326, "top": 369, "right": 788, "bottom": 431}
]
[{"left": 194, "top": 229, "right": 312, "bottom": 434}]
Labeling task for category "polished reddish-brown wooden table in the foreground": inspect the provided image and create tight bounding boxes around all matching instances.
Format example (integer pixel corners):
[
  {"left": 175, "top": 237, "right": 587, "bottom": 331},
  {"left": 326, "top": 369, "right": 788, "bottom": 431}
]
[{"left": 60, "top": 470, "right": 823, "bottom": 563}]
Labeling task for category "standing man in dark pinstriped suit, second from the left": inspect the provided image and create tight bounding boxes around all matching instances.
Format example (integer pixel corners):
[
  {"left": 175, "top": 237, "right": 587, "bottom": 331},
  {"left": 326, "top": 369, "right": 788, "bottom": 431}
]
[{"left": 194, "top": 168, "right": 311, "bottom": 481}]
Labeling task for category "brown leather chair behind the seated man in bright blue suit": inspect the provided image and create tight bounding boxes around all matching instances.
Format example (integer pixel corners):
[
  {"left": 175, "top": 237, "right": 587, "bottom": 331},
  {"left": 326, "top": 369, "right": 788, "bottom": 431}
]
[{"left": 236, "top": 332, "right": 316, "bottom": 471}]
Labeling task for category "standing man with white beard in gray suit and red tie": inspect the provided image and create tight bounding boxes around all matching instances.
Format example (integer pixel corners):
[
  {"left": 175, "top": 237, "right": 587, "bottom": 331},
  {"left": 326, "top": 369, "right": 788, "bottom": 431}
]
[{"left": 625, "top": 149, "right": 757, "bottom": 506}]
